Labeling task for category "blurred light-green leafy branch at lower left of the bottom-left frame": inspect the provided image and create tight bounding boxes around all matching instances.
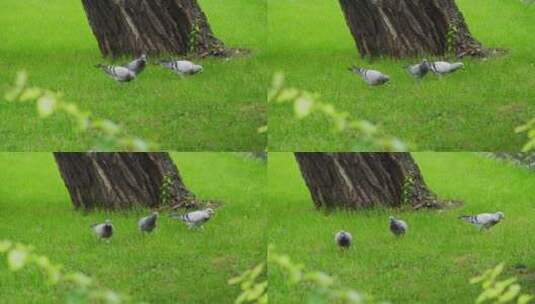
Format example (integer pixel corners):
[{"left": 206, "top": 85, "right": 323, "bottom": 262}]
[{"left": 0, "top": 240, "right": 132, "bottom": 304}]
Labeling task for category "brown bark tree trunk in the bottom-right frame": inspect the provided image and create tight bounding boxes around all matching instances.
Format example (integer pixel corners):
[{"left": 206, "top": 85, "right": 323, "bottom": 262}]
[{"left": 295, "top": 153, "right": 441, "bottom": 209}]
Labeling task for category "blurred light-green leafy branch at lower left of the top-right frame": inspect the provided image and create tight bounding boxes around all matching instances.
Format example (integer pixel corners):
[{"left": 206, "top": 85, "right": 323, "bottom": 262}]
[{"left": 270, "top": 74, "right": 407, "bottom": 152}]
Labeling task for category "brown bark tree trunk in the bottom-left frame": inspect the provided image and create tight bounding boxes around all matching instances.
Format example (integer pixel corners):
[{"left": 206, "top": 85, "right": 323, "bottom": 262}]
[{"left": 54, "top": 152, "right": 193, "bottom": 209}]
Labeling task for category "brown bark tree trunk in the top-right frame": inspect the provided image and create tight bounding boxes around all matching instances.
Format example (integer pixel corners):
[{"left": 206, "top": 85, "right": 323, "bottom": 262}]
[{"left": 340, "top": 0, "right": 487, "bottom": 58}]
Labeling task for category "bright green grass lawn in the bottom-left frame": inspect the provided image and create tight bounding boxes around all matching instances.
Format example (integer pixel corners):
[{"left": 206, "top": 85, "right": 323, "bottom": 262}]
[{"left": 0, "top": 153, "right": 267, "bottom": 304}]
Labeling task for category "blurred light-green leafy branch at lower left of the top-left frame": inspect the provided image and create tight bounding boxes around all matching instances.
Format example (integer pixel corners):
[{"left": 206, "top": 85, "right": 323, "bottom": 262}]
[{"left": 5, "top": 72, "right": 157, "bottom": 152}]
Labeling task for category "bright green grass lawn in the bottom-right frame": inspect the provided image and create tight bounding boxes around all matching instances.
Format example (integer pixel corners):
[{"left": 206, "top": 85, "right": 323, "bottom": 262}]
[{"left": 268, "top": 153, "right": 535, "bottom": 303}]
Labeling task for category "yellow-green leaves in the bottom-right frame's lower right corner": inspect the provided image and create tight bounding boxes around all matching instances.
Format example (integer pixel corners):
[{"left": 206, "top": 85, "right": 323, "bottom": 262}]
[{"left": 470, "top": 263, "right": 535, "bottom": 304}]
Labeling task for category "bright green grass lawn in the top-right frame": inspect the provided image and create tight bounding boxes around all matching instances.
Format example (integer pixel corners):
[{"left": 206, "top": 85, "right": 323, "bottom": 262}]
[{"left": 266, "top": 0, "right": 535, "bottom": 151}]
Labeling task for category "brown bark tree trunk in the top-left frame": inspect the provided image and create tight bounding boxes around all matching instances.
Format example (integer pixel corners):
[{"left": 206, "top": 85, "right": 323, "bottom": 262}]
[{"left": 82, "top": 0, "right": 226, "bottom": 57}]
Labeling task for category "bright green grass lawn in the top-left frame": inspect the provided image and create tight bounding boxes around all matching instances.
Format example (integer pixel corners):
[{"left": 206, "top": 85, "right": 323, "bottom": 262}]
[{"left": 0, "top": 0, "right": 269, "bottom": 151}]
